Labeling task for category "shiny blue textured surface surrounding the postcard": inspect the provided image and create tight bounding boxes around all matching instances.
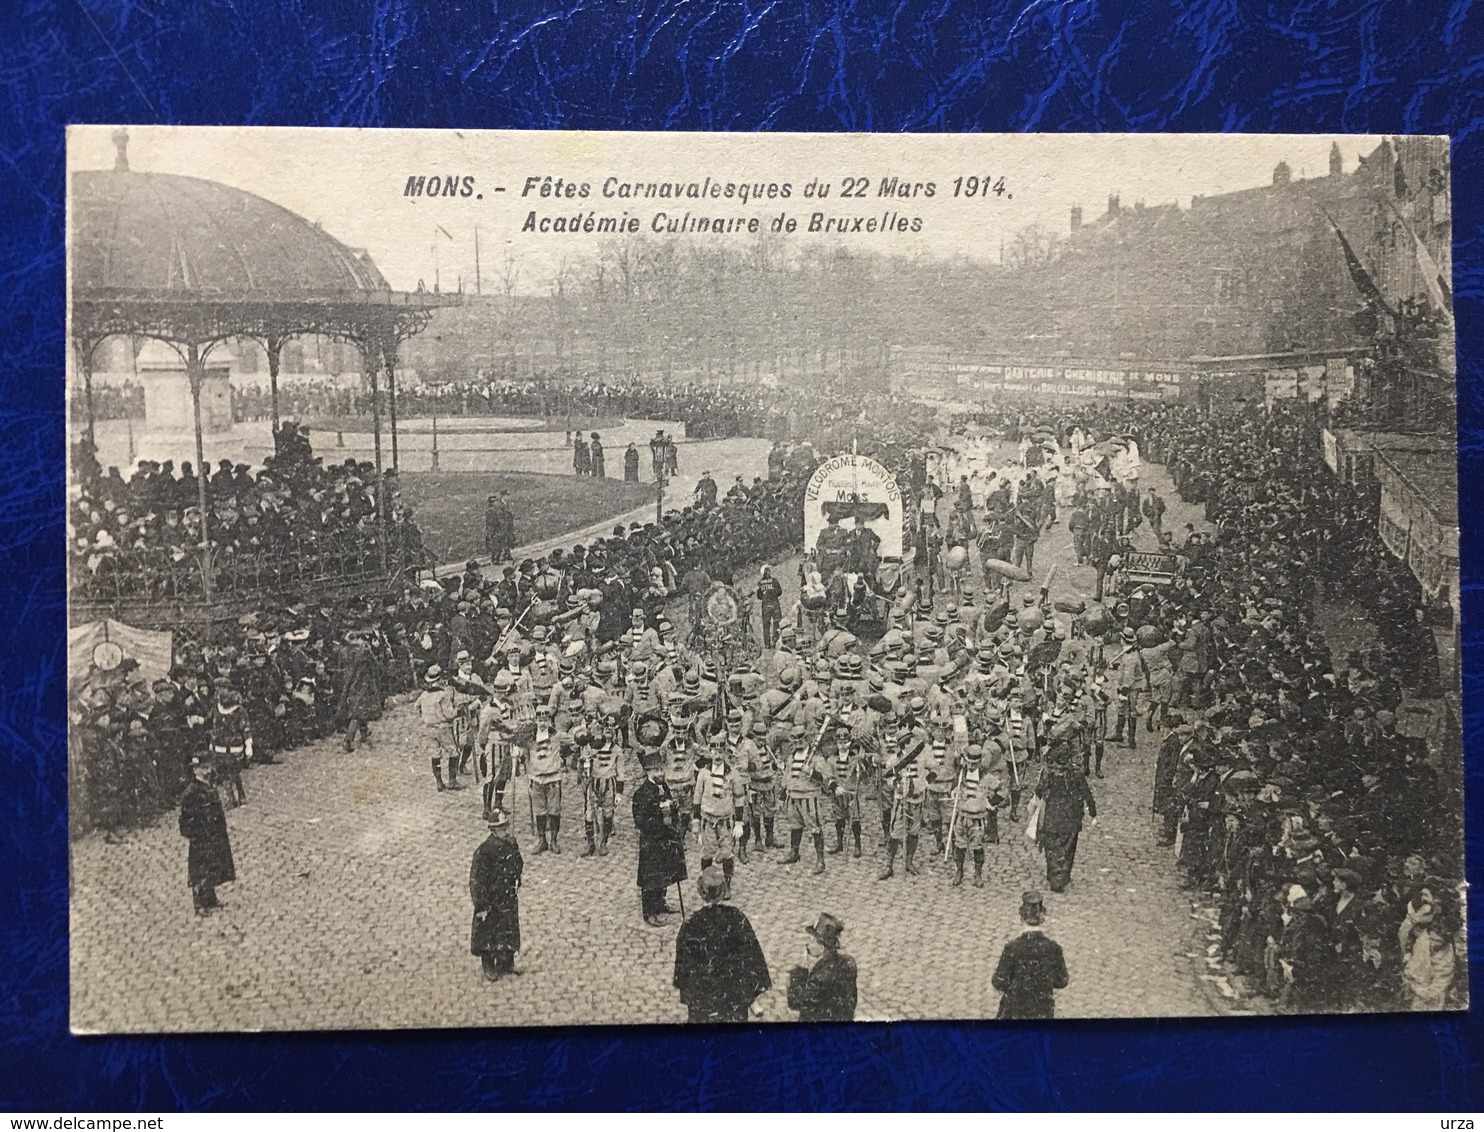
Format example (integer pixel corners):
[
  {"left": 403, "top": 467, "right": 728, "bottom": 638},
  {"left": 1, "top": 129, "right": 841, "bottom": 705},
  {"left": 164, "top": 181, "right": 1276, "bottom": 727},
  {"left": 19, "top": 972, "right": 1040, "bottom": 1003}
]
[{"left": 0, "top": 0, "right": 1484, "bottom": 1111}]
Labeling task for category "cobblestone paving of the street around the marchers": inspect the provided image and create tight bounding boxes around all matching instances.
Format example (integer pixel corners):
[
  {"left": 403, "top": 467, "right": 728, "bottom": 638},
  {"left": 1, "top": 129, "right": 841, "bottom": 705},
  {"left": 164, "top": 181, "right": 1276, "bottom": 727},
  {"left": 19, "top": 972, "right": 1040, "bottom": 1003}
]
[{"left": 71, "top": 448, "right": 1224, "bottom": 1031}]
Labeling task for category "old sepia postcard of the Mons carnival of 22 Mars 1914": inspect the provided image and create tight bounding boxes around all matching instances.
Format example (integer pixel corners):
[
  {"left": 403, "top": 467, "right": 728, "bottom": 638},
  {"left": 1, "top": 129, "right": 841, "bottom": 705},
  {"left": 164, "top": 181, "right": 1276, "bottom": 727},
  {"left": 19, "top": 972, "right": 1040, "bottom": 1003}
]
[{"left": 67, "top": 126, "right": 1468, "bottom": 1033}]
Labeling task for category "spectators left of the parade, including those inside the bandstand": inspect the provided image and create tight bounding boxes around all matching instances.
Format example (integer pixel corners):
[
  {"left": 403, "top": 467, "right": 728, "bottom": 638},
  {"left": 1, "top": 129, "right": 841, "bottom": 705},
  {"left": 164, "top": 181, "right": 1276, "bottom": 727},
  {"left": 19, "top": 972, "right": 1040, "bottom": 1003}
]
[{"left": 70, "top": 385, "right": 935, "bottom": 831}]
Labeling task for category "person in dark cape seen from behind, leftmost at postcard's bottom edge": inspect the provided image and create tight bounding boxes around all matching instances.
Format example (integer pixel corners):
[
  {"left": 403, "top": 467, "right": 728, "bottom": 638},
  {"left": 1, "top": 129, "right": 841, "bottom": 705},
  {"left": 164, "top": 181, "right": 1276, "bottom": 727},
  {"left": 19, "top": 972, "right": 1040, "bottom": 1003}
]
[{"left": 674, "top": 866, "right": 773, "bottom": 1022}]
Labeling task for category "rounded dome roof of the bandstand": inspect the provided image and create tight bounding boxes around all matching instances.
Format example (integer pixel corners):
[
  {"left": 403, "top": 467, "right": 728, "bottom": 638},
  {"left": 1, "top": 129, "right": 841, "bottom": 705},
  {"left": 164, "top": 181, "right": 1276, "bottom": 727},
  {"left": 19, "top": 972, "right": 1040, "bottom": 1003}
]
[{"left": 71, "top": 169, "right": 390, "bottom": 301}]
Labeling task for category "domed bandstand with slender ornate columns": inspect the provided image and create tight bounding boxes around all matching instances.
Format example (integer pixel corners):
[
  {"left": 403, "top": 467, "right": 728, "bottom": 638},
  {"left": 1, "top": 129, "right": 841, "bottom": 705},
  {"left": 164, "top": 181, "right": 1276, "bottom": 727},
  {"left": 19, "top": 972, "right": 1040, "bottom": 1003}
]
[{"left": 70, "top": 131, "right": 459, "bottom": 620}]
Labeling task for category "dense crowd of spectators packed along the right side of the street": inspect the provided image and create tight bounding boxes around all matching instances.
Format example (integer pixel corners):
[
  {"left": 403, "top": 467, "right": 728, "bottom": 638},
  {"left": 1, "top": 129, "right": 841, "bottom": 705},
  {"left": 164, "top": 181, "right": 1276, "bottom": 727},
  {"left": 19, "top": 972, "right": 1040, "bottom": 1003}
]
[{"left": 1123, "top": 405, "right": 1465, "bottom": 1013}]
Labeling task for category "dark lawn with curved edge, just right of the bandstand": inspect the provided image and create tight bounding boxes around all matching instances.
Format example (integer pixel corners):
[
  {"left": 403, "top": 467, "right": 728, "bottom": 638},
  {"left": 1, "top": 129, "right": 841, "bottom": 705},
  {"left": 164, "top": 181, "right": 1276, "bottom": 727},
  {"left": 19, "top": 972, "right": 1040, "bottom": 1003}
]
[{"left": 398, "top": 472, "right": 654, "bottom": 562}]
